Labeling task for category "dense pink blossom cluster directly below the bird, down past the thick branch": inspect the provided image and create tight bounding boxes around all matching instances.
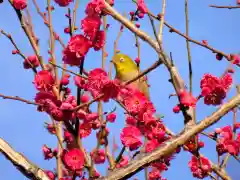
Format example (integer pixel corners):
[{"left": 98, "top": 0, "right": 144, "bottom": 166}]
[{"left": 118, "top": 86, "right": 176, "bottom": 180}]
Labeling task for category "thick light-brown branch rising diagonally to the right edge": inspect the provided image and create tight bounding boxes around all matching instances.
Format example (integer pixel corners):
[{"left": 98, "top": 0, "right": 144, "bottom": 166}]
[{"left": 98, "top": 94, "right": 240, "bottom": 180}]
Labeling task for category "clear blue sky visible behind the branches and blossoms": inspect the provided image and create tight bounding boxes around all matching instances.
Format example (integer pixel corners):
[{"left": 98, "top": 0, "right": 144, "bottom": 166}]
[{"left": 0, "top": 0, "right": 240, "bottom": 180}]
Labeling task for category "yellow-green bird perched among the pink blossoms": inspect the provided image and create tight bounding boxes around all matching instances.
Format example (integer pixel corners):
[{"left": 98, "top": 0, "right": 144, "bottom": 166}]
[{"left": 112, "top": 53, "right": 149, "bottom": 99}]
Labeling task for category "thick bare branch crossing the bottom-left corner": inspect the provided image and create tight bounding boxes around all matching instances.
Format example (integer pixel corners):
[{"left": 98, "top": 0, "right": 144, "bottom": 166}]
[{"left": 0, "top": 138, "right": 49, "bottom": 180}]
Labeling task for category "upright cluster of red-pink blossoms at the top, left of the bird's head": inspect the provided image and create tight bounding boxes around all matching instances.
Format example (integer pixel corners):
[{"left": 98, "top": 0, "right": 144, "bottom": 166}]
[{"left": 63, "top": 0, "right": 113, "bottom": 66}]
